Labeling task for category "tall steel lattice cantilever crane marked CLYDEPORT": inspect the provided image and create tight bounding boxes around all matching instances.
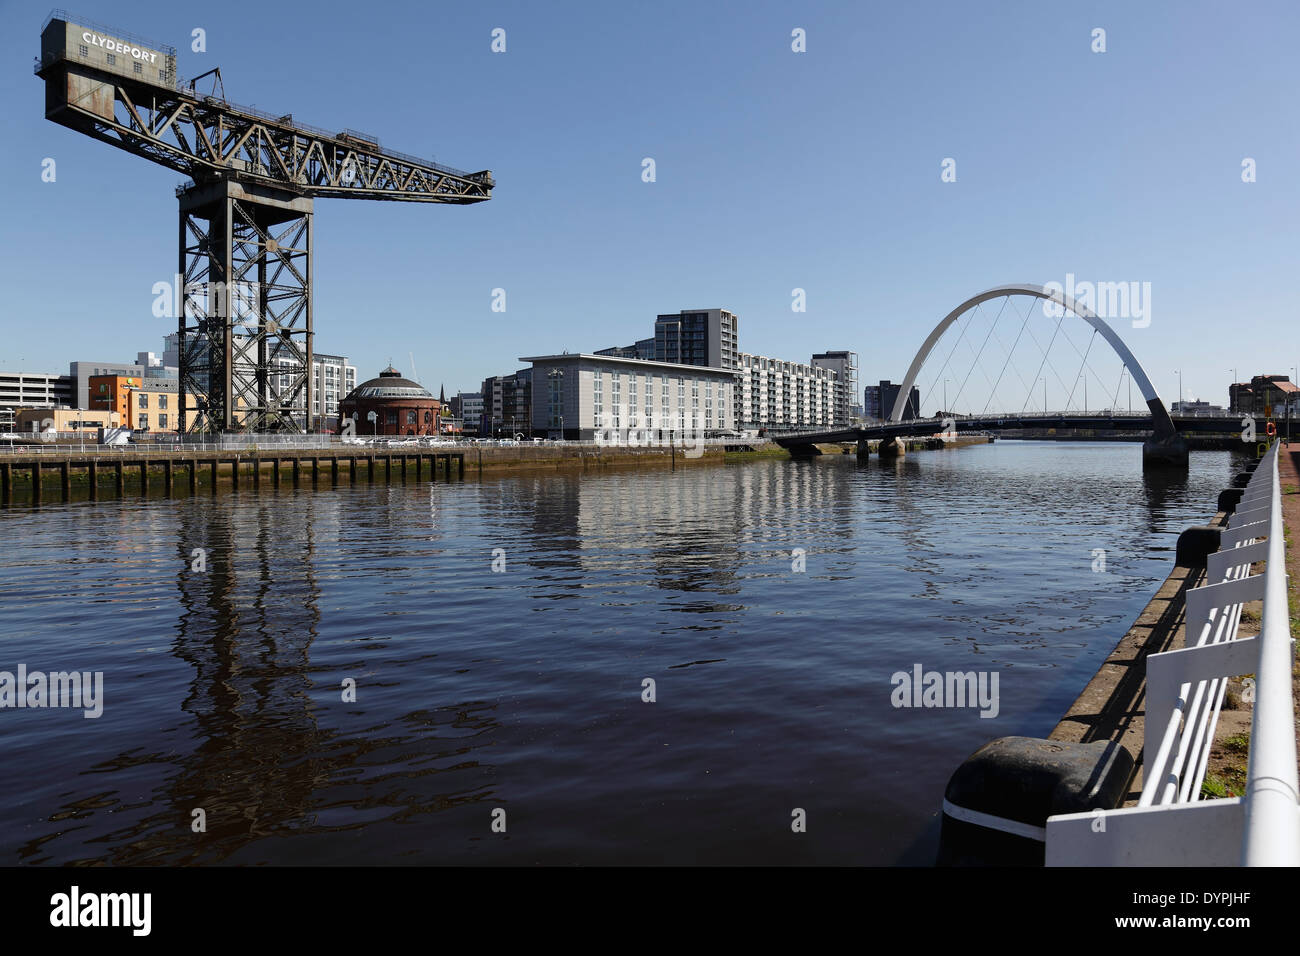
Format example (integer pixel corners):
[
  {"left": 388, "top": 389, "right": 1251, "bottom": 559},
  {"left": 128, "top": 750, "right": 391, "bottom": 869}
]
[{"left": 35, "top": 10, "right": 495, "bottom": 432}]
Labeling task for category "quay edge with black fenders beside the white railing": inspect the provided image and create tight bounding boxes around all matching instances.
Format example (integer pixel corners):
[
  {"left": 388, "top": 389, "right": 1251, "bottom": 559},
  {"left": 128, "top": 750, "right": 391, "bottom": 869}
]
[{"left": 939, "top": 452, "right": 1274, "bottom": 865}]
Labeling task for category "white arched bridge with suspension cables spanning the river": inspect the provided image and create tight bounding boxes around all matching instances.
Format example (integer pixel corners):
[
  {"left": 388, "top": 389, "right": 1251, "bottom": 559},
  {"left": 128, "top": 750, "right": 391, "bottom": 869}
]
[{"left": 774, "top": 284, "right": 1201, "bottom": 466}]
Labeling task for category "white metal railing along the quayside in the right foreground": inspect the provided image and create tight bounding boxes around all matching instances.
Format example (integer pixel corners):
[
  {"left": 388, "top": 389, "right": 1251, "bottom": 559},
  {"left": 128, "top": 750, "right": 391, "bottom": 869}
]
[{"left": 1047, "top": 442, "right": 1300, "bottom": 866}]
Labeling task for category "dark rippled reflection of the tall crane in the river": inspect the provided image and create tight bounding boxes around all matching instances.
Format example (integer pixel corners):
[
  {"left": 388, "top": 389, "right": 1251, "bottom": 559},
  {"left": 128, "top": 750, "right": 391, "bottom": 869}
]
[{"left": 18, "top": 494, "right": 499, "bottom": 865}]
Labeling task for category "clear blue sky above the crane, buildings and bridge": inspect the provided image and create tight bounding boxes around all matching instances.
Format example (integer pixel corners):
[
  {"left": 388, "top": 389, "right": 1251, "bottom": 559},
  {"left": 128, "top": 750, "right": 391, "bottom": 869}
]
[{"left": 0, "top": 0, "right": 1300, "bottom": 406}]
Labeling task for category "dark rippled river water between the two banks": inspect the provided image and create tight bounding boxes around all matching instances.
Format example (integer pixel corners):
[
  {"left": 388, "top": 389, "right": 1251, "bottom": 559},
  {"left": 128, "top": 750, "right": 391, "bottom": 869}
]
[{"left": 0, "top": 442, "right": 1240, "bottom": 865}]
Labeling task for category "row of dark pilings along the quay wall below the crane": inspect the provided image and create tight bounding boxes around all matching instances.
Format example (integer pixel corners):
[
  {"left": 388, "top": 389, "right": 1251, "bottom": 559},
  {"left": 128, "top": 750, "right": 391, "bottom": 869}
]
[{"left": 0, "top": 449, "right": 465, "bottom": 506}]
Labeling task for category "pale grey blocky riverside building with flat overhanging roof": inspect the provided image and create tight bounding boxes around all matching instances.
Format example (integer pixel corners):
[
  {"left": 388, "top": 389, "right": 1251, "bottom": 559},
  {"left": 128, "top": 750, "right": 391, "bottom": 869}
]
[{"left": 520, "top": 352, "right": 736, "bottom": 441}]
